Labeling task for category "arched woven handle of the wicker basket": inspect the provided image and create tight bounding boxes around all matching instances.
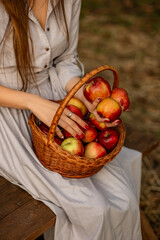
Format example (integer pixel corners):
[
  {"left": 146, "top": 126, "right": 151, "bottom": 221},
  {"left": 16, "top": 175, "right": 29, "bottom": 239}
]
[{"left": 47, "top": 65, "right": 119, "bottom": 146}]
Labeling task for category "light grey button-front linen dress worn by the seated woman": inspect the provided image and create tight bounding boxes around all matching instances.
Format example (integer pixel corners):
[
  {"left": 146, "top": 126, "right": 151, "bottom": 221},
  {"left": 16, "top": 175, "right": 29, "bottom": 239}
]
[{"left": 0, "top": 0, "right": 141, "bottom": 240}]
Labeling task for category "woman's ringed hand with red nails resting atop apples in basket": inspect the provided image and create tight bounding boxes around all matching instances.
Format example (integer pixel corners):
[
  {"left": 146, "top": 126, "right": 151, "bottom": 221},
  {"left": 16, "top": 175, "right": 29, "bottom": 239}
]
[{"left": 28, "top": 95, "right": 88, "bottom": 139}]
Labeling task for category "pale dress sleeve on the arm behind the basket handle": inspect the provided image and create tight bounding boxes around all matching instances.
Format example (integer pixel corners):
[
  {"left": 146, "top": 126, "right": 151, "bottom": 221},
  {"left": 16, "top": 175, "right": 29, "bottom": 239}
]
[{"left": 55, "top": 0, "right": 84, "bottom": 91}]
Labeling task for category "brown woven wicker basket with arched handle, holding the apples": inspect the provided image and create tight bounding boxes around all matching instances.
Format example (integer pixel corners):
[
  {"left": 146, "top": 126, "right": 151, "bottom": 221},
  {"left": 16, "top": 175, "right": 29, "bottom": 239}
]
[{"left": 29, "top": 65, "right": 125, "bottom": 178}]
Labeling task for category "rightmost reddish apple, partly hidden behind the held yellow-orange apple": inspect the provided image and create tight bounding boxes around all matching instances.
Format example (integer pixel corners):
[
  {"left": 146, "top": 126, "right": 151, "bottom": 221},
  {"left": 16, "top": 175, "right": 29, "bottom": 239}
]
[{"left": 111, "top": 88, "right": 130, "bottom": 111}]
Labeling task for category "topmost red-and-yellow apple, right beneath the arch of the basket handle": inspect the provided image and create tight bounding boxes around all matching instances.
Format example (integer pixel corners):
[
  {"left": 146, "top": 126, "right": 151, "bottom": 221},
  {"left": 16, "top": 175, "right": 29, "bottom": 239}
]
[{"left": 83, "top": 77, "right": 111, "bottom": 102}]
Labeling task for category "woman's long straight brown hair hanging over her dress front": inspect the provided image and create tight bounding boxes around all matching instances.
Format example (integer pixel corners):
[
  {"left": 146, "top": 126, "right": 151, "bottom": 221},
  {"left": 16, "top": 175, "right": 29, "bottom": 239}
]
[{"left": 0, "top": 0, "right": 69, "bottom": 91}]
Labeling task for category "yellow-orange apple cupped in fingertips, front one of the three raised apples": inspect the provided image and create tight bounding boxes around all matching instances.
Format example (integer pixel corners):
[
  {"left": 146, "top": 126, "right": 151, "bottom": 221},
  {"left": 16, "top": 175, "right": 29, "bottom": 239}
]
[{"left": 97, "top": 98, "right": 122, "bottom": 122}]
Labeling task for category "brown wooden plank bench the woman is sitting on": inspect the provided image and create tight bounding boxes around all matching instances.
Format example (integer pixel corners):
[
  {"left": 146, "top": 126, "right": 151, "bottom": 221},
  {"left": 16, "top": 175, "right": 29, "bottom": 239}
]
[{"left": 0, "top": 127, "right": 158, "bottom": 240}]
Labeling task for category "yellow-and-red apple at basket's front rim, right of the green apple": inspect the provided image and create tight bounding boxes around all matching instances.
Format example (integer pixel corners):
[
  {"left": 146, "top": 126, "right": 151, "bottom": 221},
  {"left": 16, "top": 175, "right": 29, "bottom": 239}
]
[{"left": 84, "top": 142, "right": 107, "bottom": 158}]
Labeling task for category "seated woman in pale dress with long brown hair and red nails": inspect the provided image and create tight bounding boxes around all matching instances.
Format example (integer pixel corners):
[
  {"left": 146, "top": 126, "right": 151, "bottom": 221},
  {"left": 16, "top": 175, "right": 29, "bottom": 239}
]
[{"left": 0, "top": 0, "right": 141, "bottom": 240}]
